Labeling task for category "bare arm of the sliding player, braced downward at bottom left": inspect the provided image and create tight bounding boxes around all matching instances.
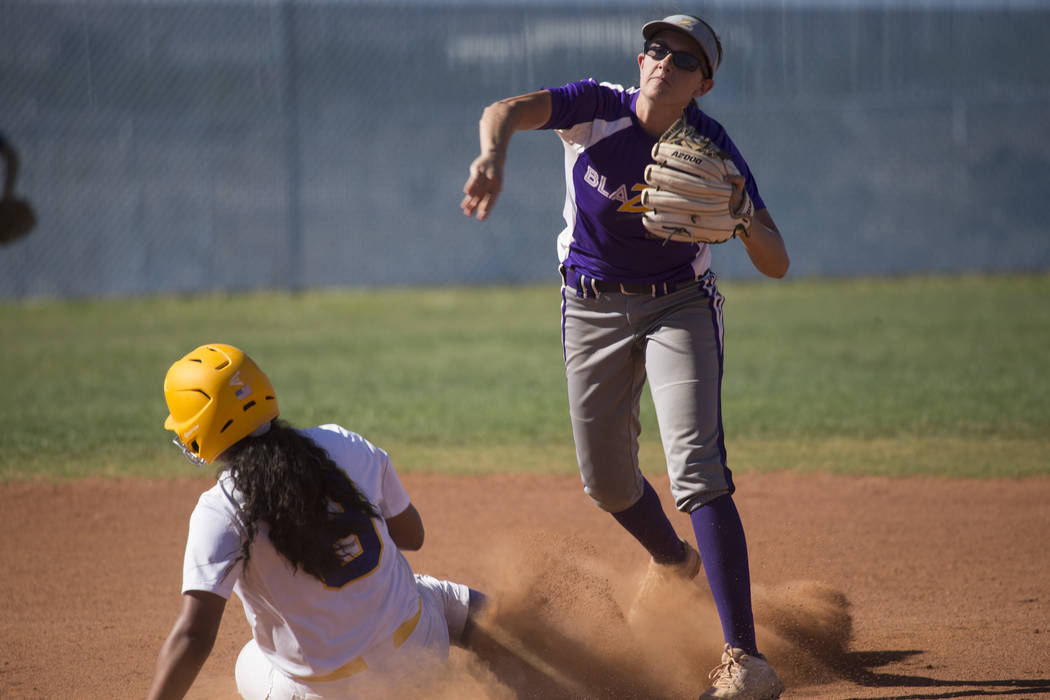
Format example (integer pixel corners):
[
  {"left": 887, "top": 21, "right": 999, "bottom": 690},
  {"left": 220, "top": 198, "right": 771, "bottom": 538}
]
[{"left": 146, "top": 591, "right": 226, "bottom": 700}]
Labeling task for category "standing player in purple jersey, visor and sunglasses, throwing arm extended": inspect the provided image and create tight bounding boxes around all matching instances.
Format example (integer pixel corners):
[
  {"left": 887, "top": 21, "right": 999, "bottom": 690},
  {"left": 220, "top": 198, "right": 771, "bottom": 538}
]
[{"left": 461, "top": 15, "right": 789, "bottom": 699}]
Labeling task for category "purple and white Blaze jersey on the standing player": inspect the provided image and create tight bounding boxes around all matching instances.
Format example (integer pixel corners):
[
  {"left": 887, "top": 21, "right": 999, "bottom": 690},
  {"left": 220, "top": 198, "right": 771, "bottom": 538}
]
[{"left": 542, "top": 80, "right": 765, "bottom": 284}]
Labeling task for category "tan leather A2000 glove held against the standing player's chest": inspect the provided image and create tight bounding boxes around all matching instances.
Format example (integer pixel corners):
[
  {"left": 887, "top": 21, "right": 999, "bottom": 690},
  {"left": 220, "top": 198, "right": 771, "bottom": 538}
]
[{"left": 642, "top": 118, "right": 755, "bottom": 243}]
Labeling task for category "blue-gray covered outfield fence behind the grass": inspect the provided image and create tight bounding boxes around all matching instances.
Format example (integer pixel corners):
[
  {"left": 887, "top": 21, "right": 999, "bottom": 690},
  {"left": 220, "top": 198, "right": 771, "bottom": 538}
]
[{"left": 0, "top": 0, "right": 1050, "bottom": 298}]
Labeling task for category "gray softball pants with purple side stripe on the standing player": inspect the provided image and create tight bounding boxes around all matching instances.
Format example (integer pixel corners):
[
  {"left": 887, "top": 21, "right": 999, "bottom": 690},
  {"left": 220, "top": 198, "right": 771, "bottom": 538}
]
[{"left": 562, "top": 272, "right": 733, "bottom": 513}]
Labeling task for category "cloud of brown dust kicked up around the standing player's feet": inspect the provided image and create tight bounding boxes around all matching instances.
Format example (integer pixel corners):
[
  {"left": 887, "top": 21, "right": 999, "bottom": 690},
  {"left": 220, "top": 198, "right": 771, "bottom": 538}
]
[{"left": 403, "top": 531, "right": 852, "bottom": 700}]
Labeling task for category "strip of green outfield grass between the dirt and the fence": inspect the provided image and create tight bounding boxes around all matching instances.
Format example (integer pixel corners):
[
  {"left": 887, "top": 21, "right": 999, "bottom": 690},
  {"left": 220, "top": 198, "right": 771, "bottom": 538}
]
[{"left": 0, "top": 275, "right": 1050, "bottom": 480}]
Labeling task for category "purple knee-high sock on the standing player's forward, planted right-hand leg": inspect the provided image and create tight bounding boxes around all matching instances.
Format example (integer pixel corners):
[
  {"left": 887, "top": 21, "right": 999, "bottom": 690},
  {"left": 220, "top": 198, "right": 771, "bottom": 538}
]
[{"left": 689, "top": 494, "right": 758, "bottom": 655}]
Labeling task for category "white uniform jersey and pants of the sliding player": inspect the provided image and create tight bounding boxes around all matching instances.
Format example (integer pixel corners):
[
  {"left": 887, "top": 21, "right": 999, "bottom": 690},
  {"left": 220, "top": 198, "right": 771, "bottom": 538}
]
[{"left": 183, "top": 425, "right": 469, "bottom": 692}]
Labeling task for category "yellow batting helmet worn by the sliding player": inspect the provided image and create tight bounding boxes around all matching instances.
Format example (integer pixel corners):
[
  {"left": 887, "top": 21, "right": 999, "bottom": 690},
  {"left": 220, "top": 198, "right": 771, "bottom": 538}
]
[{"left": 164, "top": 343, "right": 278, "bottom": 464}]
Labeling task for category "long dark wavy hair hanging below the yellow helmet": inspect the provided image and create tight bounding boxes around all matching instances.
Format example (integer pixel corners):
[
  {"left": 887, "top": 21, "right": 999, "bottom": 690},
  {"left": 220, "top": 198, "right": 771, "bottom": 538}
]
[{"left": 219, "top": 420, "right": 380, "bottom": 580}]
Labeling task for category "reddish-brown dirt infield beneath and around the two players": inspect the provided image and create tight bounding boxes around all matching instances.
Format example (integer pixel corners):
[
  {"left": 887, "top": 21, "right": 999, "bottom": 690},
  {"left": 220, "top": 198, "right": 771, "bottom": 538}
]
[{"left": 0, "top": 473, "right": 1050, "bottom": 700}]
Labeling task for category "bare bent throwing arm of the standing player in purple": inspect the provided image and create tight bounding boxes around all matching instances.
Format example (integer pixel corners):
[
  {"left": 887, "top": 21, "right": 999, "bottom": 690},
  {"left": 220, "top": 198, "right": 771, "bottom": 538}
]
[{"left": 460, "top": 90, "right": 550, "bottom": 221}]
